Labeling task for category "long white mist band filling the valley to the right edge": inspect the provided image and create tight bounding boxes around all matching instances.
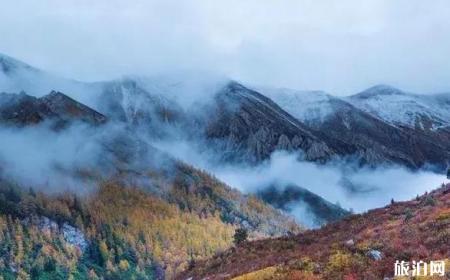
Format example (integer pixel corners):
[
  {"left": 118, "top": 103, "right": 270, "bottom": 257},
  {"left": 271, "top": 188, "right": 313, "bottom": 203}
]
[{"left": 154, "top": 139, "right": 449, "bottom": 220}]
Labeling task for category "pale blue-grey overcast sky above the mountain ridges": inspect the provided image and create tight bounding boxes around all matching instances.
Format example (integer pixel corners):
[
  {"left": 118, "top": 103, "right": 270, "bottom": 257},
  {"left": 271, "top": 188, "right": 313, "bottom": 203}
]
[{"left": 0, "top": 0, "right": 450, "bottom": 94}]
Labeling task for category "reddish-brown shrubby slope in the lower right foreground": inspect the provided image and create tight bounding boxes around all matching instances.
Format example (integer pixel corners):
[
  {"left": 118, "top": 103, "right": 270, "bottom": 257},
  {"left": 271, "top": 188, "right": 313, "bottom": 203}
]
[{"left": 182, "top": 185, "right": 450, "bottom": 280}]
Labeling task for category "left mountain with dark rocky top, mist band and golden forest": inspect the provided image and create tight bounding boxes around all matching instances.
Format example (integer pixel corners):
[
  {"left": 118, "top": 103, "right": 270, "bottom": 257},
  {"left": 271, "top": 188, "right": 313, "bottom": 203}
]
[{"left": 0, "top": 87, "right": 300, "bottom": 279}]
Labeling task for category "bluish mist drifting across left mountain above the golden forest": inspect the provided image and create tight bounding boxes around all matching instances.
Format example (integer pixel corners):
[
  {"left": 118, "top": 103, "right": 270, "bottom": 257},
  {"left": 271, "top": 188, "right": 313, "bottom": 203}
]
[{"left": 0, "top": 122, "right": 172, "bottom": 195}]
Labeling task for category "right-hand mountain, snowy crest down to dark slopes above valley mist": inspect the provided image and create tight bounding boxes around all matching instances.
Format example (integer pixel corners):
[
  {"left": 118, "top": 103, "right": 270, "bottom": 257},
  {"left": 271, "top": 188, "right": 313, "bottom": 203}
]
[{"left": 261, "top": 86, "right": 450, "bottom": 168}]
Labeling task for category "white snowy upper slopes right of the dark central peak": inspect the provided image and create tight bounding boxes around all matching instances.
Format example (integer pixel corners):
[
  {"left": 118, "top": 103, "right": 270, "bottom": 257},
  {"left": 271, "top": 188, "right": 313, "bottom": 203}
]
[{"left": 256, "top": 85, "right": 450, "bottom": 130}]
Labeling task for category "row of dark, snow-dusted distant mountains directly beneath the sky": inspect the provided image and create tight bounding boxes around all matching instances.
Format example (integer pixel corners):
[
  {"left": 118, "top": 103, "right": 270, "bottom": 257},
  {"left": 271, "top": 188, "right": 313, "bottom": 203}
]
[{"left": 0, "top": 55, "right": 450, "bottom": 170}]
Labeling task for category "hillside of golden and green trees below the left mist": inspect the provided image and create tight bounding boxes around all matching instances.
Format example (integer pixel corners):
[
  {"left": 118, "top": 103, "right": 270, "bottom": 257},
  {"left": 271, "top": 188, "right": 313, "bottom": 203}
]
[{"left": 0, "top": 165, "right": 299, "bottom": 279}]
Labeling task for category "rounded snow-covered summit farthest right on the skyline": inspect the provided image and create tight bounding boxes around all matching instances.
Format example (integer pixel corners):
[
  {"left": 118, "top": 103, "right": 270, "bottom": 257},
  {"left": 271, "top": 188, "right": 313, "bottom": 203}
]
[{"left": 346, "top": 85, "right": 450, "bottom": 130}]
